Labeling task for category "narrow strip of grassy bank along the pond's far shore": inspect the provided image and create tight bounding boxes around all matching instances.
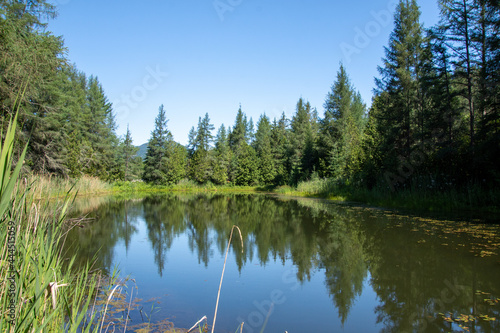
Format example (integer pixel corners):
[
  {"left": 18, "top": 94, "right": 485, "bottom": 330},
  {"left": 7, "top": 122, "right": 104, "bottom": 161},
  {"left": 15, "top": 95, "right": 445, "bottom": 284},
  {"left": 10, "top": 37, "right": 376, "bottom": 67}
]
[{"left": 31, "top": 171, "right": 500, "bottom": 213}]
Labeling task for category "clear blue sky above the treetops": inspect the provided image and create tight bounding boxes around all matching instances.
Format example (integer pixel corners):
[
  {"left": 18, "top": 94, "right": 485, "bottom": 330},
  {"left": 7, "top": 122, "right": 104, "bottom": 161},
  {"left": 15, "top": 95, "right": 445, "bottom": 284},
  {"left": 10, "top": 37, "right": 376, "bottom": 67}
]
[{"left": 48, "top": 0, "right": 438, "bottom": 145}]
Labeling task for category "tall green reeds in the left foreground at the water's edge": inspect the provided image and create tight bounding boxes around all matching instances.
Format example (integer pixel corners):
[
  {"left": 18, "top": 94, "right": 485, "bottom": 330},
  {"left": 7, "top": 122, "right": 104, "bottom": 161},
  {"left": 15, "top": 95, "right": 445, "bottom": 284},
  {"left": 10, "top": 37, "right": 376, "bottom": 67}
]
[{"left": 0, "top": 108, "right": 121, "bottom": 333}]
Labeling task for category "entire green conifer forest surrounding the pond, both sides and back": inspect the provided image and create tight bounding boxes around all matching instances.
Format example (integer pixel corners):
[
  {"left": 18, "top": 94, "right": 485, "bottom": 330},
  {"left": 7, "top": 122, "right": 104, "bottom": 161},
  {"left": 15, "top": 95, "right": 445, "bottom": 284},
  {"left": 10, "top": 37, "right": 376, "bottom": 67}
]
[{"left": 0, "top": 0, "right": 500, "bottom": 205}]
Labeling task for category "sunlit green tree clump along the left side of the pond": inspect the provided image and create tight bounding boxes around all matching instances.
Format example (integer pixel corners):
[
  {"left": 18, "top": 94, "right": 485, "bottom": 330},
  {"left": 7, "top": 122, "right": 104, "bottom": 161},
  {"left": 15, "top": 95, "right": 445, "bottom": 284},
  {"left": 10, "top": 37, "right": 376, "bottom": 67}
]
[{"left": 0, "top": 0, "right": 142, "bottom": 180}]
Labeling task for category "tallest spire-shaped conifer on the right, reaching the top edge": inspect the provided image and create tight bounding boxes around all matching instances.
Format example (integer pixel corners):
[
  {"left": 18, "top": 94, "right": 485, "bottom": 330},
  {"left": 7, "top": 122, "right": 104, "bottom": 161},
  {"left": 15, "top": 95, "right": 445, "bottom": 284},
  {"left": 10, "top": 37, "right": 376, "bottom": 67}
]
[{"left": 376, "top": 0, "right": 423, "bottom": 183}]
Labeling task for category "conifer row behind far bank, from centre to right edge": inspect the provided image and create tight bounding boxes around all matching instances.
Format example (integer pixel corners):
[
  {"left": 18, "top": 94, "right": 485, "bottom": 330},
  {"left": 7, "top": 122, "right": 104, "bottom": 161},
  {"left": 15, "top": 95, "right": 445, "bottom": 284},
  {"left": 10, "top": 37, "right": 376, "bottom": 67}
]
[{"left": 144, "top": 0, "right": 500, "bottom": 191}]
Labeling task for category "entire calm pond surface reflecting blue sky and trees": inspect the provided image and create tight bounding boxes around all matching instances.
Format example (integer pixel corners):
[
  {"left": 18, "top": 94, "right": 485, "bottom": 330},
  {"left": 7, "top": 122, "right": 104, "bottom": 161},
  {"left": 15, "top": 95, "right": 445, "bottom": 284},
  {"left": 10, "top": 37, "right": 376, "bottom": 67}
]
[{"left": 66, "top": 195, "right": 500, "bottom": 333}]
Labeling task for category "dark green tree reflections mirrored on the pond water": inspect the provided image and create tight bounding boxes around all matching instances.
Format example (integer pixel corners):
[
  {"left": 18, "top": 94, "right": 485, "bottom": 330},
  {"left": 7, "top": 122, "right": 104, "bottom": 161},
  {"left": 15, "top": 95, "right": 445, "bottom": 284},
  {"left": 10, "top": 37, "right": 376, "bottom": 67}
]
[{"left": 66, "top": 195, "right": 500, "bottom": 332}]
